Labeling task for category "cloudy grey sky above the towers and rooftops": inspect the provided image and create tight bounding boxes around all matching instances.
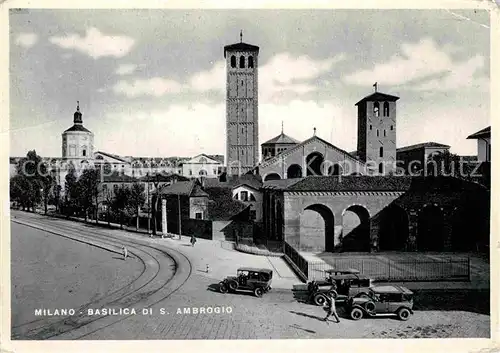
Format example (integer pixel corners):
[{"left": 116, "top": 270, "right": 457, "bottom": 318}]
[{"left": 9, "top": 9, "right": 490, "bottom": 157}]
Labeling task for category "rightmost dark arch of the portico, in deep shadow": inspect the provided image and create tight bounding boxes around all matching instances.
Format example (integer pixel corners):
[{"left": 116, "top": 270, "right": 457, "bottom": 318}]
[{"left": 417, "top": 204, "right": 444, "bottom": 251}]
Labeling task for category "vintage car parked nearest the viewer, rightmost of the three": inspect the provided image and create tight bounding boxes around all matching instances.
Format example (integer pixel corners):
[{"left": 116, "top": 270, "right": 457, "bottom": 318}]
[{"left": 346, "top": 285, "right": 413, "bottom": 321}]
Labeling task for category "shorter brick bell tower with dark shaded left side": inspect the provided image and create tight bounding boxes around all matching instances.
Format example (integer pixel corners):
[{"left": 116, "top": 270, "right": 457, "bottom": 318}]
[{"left": 356, "top": 83, "right": 399, "bottom": 175}]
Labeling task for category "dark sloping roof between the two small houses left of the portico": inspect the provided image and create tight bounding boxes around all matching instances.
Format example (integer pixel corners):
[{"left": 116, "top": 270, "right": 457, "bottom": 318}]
[{"left": 205, "top": 187, "right": 250, "bottom": 221}]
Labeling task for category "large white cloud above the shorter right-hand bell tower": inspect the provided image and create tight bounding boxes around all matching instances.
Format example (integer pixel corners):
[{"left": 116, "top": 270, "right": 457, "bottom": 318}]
[{"left": 344, "top": 38, "right": 484, "bottom": 90}]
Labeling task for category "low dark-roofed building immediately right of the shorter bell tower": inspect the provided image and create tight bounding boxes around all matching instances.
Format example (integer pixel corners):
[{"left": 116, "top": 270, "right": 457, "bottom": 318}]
[{"left": 396, "top": 142, "right": 450, "bottom": 175}]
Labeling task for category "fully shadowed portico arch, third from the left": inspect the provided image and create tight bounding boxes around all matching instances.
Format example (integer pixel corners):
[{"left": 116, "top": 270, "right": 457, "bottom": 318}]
[{"left": 378, "top": 204, "right": 409, "bottom": 251}]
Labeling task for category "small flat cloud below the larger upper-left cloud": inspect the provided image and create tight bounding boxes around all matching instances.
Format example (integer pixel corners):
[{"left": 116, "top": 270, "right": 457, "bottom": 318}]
[{"left": 113, "top": 77, "right": 183, "bottom": 98}]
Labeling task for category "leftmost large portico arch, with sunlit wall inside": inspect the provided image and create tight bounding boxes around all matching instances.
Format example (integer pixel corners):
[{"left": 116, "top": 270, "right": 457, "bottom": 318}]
[{"left": 299, "top": 204, "right": 335, "bottom": 252}]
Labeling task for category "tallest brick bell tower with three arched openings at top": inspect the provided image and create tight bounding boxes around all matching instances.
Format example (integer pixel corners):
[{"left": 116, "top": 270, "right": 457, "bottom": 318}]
[{"left": 224, "top": 32, "right": 259, "bottom": 175}]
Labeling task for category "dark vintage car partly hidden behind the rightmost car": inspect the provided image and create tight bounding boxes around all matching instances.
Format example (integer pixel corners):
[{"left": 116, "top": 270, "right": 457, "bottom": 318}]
[{"left": 307, "top": 269, "right": 372, "bottom": 306}]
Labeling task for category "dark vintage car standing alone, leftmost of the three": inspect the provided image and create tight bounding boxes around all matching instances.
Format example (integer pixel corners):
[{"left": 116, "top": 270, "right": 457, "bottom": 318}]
[{"left": 219, "top": 267, "right": 273, "bottom": 297}]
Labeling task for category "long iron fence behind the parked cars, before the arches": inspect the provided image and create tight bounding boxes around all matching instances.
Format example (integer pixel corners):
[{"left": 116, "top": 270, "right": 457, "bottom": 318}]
[{"left": 307, "top": 256, "right": 470, "bottom": 281}]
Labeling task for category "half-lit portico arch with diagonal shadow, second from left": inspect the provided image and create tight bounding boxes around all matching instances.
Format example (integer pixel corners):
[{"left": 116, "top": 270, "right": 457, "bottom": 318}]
[{"left": 341, "top": 204, "right": 371, "bottom": 251}]
